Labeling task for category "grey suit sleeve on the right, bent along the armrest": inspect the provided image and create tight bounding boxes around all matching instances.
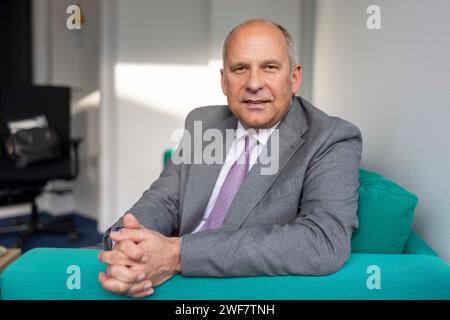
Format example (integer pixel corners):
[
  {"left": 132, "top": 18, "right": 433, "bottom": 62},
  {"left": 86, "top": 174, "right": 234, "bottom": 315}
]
[{"left": 181, "top": 122, "right": 362, "bottom": 277}]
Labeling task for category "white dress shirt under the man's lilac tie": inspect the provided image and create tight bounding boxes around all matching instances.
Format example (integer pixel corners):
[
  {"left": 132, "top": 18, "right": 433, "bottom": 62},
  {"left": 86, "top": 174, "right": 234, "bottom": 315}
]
[{"left": 192, "top": 121, "right": 280, "bottom": 233}]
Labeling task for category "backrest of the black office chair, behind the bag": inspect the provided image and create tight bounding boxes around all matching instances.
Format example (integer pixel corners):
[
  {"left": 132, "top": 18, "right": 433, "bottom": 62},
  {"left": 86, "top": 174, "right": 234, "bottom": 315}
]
[{"left": 0, "top": 86, "right": 75, "bottom": 182}]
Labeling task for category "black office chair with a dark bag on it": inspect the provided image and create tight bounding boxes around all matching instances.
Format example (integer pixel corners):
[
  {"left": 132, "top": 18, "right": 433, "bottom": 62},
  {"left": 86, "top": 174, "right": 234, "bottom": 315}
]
[{"left": 0, "top": 86, "right": 81, "bottom": 247}]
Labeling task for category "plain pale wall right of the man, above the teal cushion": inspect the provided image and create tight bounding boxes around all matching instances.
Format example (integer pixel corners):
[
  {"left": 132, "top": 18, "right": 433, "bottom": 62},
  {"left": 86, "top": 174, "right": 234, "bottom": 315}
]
[{"left": 313, "top": 0, "right": 450, "bottom": 261}]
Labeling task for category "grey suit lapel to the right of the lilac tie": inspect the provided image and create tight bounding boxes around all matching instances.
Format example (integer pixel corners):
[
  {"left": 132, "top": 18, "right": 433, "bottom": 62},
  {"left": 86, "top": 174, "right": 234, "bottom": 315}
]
[{"left": 221, "top": 97, "right": 308, "bottom": 230}]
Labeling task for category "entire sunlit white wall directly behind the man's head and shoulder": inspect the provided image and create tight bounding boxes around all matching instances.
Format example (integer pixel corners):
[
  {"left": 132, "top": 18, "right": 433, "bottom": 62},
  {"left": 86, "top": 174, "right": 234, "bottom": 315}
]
[{"left": 99, "top": 0, "right": 300, "bottom": 231}]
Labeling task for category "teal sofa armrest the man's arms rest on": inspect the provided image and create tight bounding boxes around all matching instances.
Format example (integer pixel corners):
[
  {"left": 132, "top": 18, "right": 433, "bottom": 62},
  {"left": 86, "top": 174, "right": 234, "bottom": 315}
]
[{"left": 0, "top": 248, "right": 450, "bottom": 300}]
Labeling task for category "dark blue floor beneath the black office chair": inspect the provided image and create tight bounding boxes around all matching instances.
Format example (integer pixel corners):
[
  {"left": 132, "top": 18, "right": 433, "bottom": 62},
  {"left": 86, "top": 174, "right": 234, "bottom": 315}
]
[{"left": 0, "top": 213, "right": 102, "bottom": 252}]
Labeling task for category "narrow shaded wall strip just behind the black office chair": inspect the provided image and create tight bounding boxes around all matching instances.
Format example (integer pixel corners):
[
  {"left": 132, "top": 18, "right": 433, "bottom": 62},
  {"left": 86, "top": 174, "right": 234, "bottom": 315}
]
[{"left": 46, "top": 0, "right": 100, "bottom": 218}]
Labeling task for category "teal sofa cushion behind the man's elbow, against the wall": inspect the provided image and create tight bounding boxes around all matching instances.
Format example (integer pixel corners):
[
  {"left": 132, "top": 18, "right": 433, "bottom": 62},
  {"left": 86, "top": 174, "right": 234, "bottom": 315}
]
[{"left": 352, "top": 169, "right": 418, "bottom": 253}]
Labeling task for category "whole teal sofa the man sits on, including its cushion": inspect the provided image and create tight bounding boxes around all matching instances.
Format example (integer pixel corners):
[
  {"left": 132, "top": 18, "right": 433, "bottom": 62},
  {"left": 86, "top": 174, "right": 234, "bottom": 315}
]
[{"left": 0, "top": 170, "right": 450, "bottom": 300}]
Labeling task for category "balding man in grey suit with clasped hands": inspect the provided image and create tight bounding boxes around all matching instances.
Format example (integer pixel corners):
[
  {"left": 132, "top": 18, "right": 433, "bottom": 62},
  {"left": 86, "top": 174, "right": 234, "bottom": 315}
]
[{"left": 99, "top": 20, "right": 361, "bottom": 297}]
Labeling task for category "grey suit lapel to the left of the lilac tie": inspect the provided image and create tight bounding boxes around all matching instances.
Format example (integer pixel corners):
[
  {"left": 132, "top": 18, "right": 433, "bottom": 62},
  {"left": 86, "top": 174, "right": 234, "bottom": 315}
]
[{"left": 180, "top": 115, "right": 237, "bottom": 234}]
